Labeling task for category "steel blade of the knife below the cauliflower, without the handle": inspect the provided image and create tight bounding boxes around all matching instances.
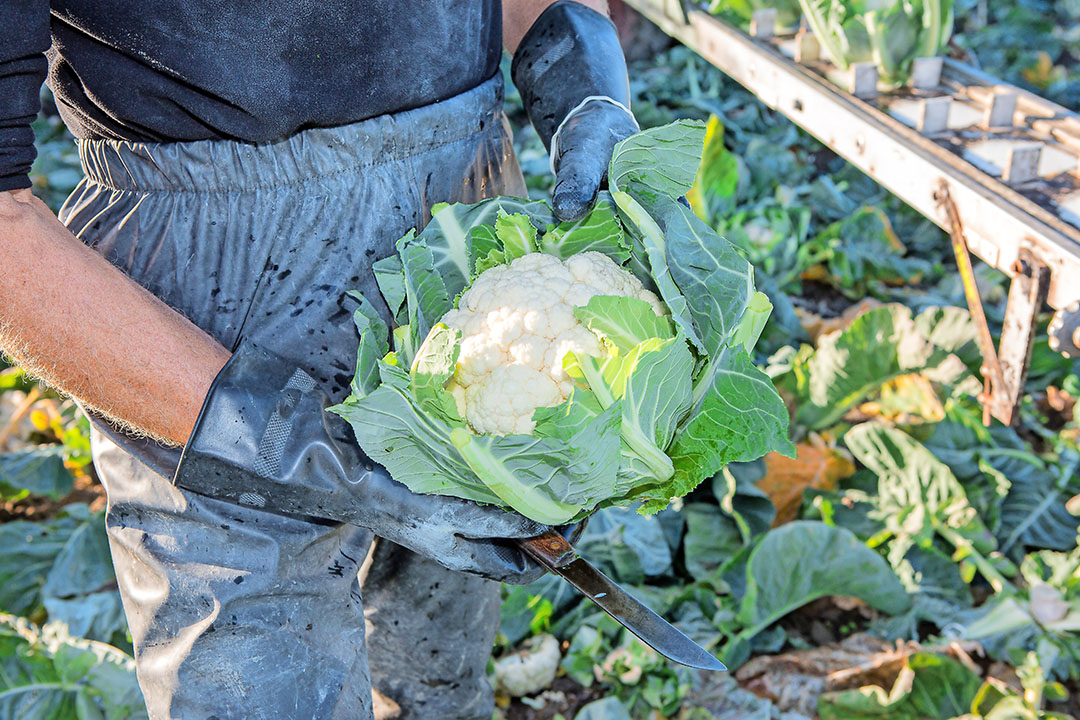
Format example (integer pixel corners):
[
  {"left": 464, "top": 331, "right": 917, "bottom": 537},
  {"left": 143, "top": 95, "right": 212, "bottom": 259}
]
[{"left": 549, "top": 558, "right": 728, "bottom": 670}]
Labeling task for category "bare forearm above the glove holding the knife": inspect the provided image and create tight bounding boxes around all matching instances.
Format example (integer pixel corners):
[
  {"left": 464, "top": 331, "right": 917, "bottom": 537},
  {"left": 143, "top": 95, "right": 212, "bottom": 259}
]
[{"left": 0, "top": 190, "right": 229, "bottom": 444}]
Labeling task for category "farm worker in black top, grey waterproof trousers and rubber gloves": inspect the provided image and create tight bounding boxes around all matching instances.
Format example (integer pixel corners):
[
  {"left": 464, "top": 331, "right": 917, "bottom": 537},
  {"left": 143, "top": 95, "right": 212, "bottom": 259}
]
[{"left": 0, "top": 0, "right": 636, "bottom": 720}]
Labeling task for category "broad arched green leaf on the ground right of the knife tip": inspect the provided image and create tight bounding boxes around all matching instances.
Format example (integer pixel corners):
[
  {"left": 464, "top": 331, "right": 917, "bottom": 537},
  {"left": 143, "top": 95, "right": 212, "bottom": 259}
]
[{"left": 739, "top": 520, "right": 912, "bottom": 635}]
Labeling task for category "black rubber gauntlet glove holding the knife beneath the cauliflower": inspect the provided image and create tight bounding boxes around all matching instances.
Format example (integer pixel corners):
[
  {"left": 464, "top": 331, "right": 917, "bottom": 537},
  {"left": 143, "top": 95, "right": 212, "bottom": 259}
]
[{"left": 174, "top": 343, "right": 548, "bottom": 584}]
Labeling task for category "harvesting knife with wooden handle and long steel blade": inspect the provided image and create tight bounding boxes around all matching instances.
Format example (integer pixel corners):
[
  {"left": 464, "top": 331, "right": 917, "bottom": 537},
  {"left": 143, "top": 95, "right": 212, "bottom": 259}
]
[{"left": 517, "top": 530, "right": 728, "bottom": 670}]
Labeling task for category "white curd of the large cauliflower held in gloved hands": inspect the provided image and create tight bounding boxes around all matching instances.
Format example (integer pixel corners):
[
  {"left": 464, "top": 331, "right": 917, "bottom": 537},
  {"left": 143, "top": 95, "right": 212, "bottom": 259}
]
[{"left": 442, "top": 253, "right": 665, "bottom": 435}]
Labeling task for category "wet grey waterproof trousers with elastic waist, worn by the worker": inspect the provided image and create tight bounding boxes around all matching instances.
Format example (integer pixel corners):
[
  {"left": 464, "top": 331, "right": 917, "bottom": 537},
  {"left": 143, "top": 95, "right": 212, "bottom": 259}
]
[{"left": 60, "top": 78, "right": 525, "bottom": 720}]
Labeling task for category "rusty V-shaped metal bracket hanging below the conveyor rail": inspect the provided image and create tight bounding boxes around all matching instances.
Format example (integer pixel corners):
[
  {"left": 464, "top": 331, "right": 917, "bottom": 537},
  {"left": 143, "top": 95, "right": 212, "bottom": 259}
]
[{"left": 935, "top": 179, "right": 1050, "bottom": 426}]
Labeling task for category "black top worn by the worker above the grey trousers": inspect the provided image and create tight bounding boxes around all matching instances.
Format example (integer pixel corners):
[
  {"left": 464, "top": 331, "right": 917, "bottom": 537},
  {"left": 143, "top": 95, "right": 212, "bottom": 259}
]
[{"left": 0, "top": 0, "right": 502, "bottom": 190}]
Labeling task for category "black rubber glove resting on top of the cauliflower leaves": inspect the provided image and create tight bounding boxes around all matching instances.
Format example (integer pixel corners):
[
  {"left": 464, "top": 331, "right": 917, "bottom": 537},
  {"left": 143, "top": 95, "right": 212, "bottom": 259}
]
[{"left": 511, "top": 0, "right": 638, "bottom": 220}]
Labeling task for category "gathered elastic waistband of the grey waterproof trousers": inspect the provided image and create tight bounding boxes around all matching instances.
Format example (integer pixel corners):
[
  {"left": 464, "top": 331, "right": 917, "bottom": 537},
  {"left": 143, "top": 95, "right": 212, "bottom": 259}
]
[{"left": 78, "top": 73, "right": 502, "bottom": 193}]
